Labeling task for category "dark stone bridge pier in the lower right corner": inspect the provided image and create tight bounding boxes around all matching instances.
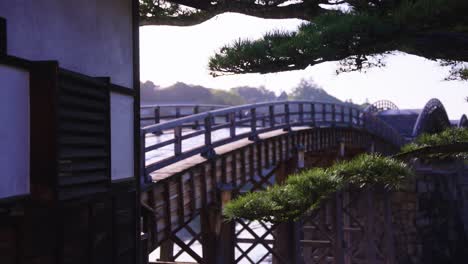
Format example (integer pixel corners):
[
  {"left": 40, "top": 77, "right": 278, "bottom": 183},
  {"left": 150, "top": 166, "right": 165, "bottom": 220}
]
[{"left": 392, "top": 161, "right": 468, "bottom": 264}]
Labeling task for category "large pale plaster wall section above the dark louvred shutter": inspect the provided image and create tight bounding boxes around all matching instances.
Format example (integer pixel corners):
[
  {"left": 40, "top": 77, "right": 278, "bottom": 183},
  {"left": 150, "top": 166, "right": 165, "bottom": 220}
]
[{"left": 0, "top": 0, "right": 133, "bottom": 87}]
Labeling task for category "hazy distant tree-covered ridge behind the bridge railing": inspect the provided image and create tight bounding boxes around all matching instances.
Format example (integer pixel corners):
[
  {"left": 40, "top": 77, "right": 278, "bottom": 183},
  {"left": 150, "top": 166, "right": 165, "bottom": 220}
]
[{"left": 140, "top": 80, "right": 342, "bottom": 105}]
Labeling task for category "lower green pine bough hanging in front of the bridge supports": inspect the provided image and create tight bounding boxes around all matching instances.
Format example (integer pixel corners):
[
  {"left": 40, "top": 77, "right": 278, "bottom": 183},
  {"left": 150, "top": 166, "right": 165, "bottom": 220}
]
[{"left": 223, "top": 155, "right": 412, "bottom": 222}]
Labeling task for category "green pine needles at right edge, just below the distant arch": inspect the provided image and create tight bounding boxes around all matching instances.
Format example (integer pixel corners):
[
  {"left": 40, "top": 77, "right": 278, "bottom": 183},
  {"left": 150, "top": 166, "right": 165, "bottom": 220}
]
[{"left": 401, "top": 128, "right": 468, "bottom": 159}]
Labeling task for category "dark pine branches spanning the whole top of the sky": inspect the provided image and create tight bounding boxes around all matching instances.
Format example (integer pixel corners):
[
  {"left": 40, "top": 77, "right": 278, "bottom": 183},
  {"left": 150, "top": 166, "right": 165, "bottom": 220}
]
[{"left": 140, "top": 0, "right": 468, "bottom": 79}]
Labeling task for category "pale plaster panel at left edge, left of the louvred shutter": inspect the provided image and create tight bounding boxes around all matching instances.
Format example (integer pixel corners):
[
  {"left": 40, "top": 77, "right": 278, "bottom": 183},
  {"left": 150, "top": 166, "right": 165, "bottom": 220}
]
[{"left": 0, "top": 65, "right": 29, "bottom": 198}]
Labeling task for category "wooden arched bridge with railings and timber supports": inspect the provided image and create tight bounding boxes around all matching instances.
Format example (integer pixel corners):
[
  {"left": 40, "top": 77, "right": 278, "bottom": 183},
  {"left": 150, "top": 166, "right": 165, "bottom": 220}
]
[{"left": 141, "top": 101, "right": 467, "bottom": 263}]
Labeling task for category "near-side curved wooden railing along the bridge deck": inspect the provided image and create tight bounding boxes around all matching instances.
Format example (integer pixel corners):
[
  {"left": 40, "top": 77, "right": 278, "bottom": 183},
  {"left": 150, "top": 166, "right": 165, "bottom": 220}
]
[{"left": 140, "top": 101, "right": 403, "bottom": 183}]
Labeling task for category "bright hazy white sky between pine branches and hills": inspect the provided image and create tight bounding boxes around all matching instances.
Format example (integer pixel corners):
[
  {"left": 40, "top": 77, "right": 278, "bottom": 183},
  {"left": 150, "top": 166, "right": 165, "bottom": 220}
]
[{"left": 140, "top": 13, "right": 468, "bottom": 119}]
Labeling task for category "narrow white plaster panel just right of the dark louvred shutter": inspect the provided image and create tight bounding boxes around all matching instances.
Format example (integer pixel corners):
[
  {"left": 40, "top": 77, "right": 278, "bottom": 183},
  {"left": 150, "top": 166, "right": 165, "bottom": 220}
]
[{"left": 110, "top": 93, "right": 134, "bottom": 180}]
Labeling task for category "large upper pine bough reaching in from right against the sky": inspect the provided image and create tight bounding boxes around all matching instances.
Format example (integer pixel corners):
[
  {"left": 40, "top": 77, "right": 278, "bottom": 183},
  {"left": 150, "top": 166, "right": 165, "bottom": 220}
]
[{"left": 209, "top": 0, "right": 468, "bottom": 76}]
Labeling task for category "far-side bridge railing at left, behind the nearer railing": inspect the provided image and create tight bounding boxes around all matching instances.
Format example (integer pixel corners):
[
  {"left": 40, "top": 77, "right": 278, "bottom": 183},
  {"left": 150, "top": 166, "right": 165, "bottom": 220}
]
[{"left": 140, "top": 104, "right": 228, "bottom": 126}]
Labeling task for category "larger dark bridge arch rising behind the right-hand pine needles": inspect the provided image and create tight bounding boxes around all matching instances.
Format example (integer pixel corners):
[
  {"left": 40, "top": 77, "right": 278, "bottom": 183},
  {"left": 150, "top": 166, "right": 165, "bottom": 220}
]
[{"left": 413, "top": 98, "right": 451, "bottom": 137}]
